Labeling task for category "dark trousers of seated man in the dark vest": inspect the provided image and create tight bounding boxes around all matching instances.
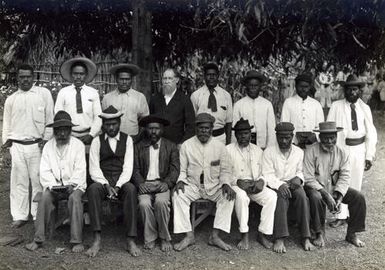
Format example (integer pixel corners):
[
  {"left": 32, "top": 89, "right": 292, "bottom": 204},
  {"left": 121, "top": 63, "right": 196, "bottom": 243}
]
[{"left": 87, "top": 182, "right": 138, "bottom": 237}]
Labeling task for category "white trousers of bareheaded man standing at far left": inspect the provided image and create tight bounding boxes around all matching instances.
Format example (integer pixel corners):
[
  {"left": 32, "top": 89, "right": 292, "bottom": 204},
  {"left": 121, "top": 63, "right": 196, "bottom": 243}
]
[{"left": 10, "top": 143, "right": 42, "bottom": 220}]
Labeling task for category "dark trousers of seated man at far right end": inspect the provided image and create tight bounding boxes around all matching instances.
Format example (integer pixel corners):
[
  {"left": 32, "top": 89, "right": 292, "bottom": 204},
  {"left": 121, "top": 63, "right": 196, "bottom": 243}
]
[{"left": 306, "top": 188, "right": 366, "bottom": 233}]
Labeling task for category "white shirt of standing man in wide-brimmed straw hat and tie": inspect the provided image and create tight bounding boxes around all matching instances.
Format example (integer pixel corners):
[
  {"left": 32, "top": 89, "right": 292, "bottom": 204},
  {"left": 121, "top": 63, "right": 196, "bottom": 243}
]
[{"left": 55, "top": 84, "right": 102, "bottom": 137}]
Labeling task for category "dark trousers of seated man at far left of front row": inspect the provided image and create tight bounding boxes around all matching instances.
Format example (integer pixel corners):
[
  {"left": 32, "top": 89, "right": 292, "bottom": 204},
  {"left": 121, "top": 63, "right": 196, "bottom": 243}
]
[{"left": 34, "top": 189, "right": 84, "bottom": 244}]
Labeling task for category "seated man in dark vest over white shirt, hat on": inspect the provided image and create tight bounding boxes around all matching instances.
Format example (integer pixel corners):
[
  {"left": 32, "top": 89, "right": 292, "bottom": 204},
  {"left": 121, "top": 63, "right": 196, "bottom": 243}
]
[{"left": 87, "top": 106, "right": 140, "bottom": 257}]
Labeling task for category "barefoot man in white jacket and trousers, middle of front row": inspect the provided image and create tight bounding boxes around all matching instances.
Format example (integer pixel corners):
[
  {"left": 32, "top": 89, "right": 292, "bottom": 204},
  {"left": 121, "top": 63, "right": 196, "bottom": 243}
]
[{"left": 172, "top": 113, "right": 235, "bottom": 251}]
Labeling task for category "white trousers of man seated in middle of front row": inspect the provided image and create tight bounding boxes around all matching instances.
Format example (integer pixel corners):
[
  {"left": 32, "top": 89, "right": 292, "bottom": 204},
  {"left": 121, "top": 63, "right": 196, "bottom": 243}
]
[{"left": 172, "top": 184, "right": 234, "bottom": 233}]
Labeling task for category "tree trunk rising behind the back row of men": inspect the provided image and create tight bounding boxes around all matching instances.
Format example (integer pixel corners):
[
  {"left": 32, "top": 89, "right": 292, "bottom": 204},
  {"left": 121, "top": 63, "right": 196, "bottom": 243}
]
[{"left": 132, "top": 0, "right": 152, "bottom": 100}]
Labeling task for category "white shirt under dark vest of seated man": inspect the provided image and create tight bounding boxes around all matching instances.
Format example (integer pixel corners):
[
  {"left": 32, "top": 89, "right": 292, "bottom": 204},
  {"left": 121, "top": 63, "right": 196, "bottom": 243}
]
[{"left": 90, "top": 133, "right": 134, "bottom": 187}]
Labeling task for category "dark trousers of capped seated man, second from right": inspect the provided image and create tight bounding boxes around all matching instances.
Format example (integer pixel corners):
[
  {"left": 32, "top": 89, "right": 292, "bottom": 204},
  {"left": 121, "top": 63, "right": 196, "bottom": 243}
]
[{"left": 274, "top": 187, "right": 311, "bottom": 239}]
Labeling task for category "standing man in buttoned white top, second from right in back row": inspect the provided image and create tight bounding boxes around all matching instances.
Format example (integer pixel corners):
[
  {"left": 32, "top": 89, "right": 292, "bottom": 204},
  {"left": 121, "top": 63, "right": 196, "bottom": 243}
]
[{"left": 281, "top": 74, "right": 325, "bottom": 149}]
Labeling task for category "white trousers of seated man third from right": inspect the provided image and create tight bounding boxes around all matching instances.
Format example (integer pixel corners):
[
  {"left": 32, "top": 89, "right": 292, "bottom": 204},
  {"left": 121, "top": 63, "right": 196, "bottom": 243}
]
[{"left": 232, "top": 186, "right": 277, "bottom": 235}]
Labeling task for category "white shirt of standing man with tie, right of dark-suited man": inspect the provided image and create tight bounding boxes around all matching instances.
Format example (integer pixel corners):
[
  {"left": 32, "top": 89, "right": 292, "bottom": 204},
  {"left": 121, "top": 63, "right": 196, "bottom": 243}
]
[{"left": 191, "top": 85, "right": 233, "bottom": 130}]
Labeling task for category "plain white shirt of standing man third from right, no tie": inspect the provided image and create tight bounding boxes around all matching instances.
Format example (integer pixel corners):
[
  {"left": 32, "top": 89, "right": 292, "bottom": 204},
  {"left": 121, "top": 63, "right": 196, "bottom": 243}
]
[{"left": 233, "top": 96, "right": 276, "bottom": 148}]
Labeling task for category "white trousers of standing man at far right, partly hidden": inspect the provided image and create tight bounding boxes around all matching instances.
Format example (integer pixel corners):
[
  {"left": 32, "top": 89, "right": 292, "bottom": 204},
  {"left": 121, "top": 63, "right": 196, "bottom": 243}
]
[{"left": 337, "top": 143, "right": 366, "bottom": 219}]
